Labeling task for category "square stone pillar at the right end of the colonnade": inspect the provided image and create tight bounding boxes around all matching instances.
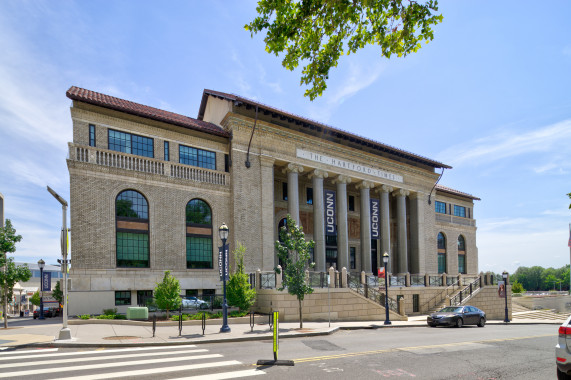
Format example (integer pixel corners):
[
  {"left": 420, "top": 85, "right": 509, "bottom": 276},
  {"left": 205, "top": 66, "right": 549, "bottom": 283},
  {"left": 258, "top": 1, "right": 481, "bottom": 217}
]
[{"left": 410, "top": 192, "right": 426, "bottom": 273}]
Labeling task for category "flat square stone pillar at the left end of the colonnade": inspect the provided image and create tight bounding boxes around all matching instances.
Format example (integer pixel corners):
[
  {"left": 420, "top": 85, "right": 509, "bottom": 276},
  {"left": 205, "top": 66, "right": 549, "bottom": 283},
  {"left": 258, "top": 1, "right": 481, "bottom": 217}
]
[{"left": 260, "top": 156, "right": 278, "bottom": 271}]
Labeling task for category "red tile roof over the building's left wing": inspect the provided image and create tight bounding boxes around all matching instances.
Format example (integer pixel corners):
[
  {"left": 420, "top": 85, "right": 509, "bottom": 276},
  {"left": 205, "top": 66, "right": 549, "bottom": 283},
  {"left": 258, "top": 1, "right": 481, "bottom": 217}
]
[{"left": 66, "top": 86, "right": 230, "bottom": 137}]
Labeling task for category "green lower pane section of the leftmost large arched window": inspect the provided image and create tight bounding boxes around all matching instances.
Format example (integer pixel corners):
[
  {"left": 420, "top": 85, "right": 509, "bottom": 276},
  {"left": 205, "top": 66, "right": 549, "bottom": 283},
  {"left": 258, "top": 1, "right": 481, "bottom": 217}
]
[{"left": 117, "top": 231, "right": 149, "bottom": 268}]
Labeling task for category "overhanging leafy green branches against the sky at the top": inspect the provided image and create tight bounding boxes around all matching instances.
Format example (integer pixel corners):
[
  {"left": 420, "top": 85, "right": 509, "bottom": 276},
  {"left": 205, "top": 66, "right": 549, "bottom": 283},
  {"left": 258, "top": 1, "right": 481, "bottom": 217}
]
[{"left": 244, "top": 0, "right": 443, "bottom": 100}]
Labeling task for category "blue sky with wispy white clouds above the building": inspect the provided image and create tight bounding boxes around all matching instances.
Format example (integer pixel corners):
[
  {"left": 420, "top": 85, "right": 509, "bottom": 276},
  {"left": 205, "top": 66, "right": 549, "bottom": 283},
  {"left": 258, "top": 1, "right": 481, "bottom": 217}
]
[{"left": 0, "top": 0, "right": 571, "bottom": 272}]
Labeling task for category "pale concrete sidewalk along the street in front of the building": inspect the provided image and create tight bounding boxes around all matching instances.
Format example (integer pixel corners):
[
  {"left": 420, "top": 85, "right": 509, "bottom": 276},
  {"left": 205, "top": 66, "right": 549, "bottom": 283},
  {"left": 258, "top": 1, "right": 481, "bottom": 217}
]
[{"left": 0, "top": 316, "right": 562, "bottom": 352}]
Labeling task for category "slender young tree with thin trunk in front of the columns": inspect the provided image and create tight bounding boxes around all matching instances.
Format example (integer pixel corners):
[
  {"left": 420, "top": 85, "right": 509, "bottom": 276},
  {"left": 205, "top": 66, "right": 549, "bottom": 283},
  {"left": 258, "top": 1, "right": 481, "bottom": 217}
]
[{"left": 275, "top": 214, "right": 315, "bottom": 328}]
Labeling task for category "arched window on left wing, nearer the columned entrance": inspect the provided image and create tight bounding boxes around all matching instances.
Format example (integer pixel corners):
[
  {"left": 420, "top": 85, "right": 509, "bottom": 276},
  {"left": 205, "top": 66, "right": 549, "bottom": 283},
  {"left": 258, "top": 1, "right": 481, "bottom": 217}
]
[{"left": 186, "top": 199, "right": 212, "bottom": 269}]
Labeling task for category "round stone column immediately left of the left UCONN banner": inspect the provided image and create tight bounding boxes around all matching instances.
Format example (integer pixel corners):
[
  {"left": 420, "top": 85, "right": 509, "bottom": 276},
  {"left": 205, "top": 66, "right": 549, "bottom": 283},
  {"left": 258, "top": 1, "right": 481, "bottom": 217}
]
[{"left": 309, "top": 169, "right": 329, "bottom": 272}]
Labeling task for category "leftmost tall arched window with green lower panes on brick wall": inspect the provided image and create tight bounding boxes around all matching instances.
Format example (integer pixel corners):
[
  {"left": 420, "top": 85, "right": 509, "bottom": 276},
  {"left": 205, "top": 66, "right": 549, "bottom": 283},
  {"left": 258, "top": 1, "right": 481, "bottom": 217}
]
[{"left": 115, "top": 190, "right": 149, "bottom": 268}]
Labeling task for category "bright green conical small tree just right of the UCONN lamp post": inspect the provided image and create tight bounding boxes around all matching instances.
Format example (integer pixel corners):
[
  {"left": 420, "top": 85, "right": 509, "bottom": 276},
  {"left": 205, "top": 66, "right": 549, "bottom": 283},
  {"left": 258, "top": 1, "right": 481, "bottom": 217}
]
[{"left": 226, "top": 242, "right": 256, "bottom": 311}]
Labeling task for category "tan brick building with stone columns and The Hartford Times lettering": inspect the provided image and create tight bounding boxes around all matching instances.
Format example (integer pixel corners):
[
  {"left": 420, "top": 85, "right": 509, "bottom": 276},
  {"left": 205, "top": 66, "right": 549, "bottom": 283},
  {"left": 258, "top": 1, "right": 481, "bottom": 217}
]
[{"left": 67, "top": 87, "right": 478, "bottom": 314}]
